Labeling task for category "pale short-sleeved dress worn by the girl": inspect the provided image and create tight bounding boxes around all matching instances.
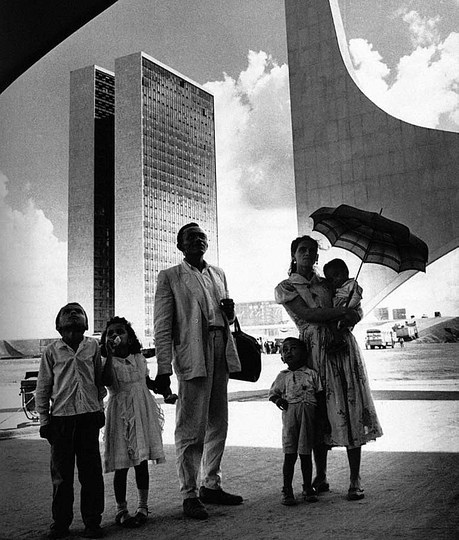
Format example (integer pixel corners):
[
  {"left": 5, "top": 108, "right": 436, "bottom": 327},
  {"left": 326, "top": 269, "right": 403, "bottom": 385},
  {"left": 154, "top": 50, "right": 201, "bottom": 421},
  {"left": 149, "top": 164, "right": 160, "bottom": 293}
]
[{"left": 104, "top": 354, "right": 165, "bottom": 472}]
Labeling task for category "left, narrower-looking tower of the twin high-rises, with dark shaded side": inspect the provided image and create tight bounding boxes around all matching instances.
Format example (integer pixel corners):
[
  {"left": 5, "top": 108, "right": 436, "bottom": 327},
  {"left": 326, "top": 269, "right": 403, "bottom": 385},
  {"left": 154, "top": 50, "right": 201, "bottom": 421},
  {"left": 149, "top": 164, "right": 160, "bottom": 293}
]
[{"left": 68, "top": 66, "right": 115, "bottom": 332}]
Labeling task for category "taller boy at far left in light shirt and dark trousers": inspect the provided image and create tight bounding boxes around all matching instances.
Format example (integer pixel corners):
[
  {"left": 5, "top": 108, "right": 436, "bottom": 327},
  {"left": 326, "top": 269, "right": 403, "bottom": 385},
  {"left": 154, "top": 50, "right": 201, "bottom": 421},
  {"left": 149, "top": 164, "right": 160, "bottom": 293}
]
[{"left": 35, "top": 302, "right": 106, "bottom": 538}]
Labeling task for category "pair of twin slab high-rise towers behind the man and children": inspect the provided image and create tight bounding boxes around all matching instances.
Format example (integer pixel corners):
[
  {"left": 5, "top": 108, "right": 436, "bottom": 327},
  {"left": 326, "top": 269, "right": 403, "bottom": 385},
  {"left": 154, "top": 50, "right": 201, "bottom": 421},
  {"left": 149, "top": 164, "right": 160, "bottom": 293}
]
[{"left": 69, "top": 53, "right": 218, "bottom": 346}]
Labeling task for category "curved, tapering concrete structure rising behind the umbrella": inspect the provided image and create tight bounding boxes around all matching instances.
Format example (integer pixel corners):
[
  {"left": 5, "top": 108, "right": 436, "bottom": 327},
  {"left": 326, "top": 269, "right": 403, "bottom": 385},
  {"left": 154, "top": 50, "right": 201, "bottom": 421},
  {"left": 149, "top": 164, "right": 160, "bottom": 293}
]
[{"left": 285, "top": 0, "right": 459, "bottom": 311}]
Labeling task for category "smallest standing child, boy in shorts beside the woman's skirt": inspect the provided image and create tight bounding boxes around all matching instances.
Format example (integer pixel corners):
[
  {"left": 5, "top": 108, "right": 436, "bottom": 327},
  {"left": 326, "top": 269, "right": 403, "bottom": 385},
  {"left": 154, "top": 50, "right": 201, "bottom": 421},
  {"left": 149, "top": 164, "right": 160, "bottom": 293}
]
[{"left": 269, "top": 337, "right": 322, "bottom": 506}]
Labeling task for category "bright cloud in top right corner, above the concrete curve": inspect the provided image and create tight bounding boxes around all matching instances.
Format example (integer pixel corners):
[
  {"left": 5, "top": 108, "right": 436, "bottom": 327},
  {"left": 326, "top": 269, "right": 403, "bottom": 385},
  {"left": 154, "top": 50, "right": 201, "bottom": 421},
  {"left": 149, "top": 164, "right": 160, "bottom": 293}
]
[{"left": 349, "top": 11, "right": 459, "bottom": 129}]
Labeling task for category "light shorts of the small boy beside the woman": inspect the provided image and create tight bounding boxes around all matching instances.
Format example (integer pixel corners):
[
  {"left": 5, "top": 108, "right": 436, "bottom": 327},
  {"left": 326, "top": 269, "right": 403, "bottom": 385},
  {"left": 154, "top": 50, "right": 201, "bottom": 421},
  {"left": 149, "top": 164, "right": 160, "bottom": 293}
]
[{"left": 282, "top": 403, "right": 316, "bottom": 454}]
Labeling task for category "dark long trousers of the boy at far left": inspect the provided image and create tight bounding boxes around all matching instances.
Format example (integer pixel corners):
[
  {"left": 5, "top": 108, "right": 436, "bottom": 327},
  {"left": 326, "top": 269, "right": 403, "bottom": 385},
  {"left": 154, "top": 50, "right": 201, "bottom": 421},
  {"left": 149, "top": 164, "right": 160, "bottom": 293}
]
[{"left": 51, "top": 413, "right": 104, "bottom": 529}]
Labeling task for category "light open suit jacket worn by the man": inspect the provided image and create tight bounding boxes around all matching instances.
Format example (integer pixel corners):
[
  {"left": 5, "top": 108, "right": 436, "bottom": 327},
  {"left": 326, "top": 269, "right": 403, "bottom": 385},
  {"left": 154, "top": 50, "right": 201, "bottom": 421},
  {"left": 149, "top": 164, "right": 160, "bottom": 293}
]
[{"left": 154, "top": 263, "right": 241, "bottom": 380}]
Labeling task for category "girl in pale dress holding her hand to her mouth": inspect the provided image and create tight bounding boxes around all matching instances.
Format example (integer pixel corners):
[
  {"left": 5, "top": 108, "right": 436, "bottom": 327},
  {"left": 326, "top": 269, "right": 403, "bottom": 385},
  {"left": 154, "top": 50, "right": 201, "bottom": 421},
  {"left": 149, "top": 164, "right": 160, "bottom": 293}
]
[{"left": 101, "top": 317, "right": 165, "bottom": 528}]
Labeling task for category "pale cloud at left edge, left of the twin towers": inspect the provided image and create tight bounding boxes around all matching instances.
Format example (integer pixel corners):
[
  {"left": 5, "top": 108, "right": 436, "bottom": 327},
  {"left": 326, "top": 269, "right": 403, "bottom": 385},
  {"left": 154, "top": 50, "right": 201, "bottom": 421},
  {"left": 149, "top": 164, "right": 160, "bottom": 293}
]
[{"left": 0, "top": 172, "right": 67, "bottom": 339}]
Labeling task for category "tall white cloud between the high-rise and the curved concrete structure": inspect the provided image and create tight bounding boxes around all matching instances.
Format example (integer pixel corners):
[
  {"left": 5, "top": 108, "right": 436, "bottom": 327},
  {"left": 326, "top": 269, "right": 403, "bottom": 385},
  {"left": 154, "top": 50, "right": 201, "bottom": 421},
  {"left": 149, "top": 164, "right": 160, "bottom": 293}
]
[{"left": 205, "top": 51, "right": 297, "bottom": 302}]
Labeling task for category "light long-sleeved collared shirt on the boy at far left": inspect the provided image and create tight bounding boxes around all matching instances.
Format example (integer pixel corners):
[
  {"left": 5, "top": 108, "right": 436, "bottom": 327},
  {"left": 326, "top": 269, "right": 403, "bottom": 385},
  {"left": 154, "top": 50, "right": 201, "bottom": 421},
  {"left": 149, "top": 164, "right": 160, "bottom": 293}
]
[{"left": 35, "top": 337, "right": 101, "bottom": 421}]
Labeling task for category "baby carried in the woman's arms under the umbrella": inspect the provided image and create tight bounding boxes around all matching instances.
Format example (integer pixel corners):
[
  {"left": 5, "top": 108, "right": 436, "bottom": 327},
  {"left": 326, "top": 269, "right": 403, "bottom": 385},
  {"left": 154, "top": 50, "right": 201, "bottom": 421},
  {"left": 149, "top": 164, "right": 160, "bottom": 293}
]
[{"left": 324, "top": 259, "right": 362, "bottom": 352}]
